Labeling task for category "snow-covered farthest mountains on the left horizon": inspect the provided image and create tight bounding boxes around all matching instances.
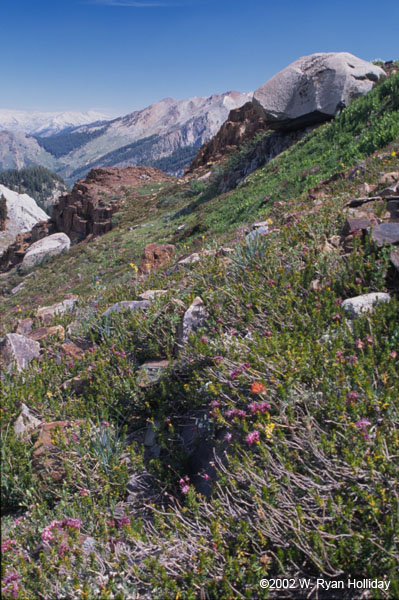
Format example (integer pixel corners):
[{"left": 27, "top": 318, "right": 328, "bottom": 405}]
[{"left": 0, "top": 108, "right": 111, "bottom": 136}]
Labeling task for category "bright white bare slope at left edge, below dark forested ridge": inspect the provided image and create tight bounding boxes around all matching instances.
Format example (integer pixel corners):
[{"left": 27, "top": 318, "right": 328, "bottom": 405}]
[{"left": 0, "top": 184, "right": 49, "bottom": 254}]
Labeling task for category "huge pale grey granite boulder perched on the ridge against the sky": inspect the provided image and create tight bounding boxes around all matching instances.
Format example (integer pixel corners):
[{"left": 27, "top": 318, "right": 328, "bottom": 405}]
[{"left": 253, "top": 52, "right": 385, "bottom": 129}]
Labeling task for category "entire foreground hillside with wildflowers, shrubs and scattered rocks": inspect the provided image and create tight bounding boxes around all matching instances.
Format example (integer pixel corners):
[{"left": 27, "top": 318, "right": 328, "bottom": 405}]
[{"left": 0, "top": 68, "right": 399, "bottom": 600}]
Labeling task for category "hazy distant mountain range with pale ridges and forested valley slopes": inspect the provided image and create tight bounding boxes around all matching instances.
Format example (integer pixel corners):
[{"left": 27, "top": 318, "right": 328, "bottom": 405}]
[{"left": 0, "top": 91, "right": 252, "bottom": 183}]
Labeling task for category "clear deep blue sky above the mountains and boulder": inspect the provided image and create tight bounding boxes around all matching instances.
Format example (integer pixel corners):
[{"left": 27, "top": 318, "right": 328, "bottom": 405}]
[{"left": 0, "top": 0, "right": 399, "bottom": 115}]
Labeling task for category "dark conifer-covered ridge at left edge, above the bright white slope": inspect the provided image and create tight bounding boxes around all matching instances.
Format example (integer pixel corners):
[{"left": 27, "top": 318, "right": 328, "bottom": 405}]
[{"left": 0, "top": 167, "right": 66, "bottom": 209}]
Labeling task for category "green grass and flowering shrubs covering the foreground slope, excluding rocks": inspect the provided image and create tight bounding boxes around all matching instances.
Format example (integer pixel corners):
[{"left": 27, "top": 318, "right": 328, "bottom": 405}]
[{"left": 2, "top": 76, "right": 399, "bottom": 600}]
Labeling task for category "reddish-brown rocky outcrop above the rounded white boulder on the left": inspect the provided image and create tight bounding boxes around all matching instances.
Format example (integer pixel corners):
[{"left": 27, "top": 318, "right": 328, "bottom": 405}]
[{"left": 52, "top": 167, "right": 170, "bottom": 241}]
